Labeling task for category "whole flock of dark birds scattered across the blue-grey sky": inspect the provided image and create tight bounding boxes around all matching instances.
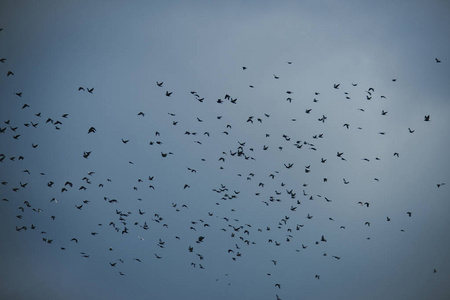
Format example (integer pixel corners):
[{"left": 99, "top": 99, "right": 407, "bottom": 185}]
[{"left": 0, "top": 26, "right": 445, "bottom": 299}]
